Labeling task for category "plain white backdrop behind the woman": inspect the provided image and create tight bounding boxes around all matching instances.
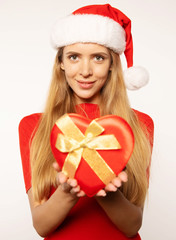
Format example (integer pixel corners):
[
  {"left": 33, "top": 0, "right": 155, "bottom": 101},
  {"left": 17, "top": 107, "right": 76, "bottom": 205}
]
[{"left": 0, "top": 0, "right": 176, "bottom": 240}]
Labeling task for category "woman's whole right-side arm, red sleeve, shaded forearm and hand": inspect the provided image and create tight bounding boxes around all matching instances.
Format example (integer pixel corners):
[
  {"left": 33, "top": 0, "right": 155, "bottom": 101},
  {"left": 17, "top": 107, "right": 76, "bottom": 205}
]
[{"left": 96, "top": 110, "right": 154, "bottom": 237}]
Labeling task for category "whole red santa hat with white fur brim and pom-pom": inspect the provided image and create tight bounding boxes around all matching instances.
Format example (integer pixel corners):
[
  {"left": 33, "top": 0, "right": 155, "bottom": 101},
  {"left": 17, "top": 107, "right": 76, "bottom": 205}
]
[{"left": 51, "top": 4, "right": 149, "bottom": 90}]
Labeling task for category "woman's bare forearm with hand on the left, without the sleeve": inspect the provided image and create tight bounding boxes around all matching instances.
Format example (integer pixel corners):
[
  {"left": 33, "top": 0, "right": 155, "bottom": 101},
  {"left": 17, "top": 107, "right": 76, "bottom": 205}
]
[{"left": 28, "top": 164, "right": 84, "bottom": 237}]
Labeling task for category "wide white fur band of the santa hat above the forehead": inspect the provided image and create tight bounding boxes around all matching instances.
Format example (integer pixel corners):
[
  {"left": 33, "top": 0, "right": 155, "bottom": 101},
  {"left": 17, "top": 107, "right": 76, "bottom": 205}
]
[{"left": 51, "top": 14, "right": 126, "bottom": 54}]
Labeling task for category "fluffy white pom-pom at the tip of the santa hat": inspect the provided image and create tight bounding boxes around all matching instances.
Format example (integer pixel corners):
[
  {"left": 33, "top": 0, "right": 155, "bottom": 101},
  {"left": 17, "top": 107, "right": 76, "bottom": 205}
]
[{"left": 124, "top": 66, "right": 149, "bottom": 90}]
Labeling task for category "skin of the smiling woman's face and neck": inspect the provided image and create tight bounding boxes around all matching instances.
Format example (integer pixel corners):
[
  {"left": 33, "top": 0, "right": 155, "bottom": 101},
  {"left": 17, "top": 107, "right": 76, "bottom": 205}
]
[{"left": 61, "top": 43, "right": 111, "bottom": 104}]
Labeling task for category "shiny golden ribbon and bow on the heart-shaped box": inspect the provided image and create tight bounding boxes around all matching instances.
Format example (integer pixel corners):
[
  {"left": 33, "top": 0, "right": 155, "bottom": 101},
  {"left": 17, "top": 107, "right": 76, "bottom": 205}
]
[{"left": 56, "top": 114, "right": 121, "bottom": 185}]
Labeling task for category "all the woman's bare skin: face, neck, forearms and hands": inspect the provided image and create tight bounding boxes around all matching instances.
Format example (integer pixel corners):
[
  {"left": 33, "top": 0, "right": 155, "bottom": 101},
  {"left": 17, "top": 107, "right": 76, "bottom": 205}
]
[{"left": 28, "top": 43, "right": 143, "bottom": 237}]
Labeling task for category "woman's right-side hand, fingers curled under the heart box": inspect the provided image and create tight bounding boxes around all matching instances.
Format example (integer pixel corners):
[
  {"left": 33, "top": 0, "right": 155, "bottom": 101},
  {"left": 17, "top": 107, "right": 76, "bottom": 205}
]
[{"left": 96, "top": 171, "right": 128, "bottom": 197}]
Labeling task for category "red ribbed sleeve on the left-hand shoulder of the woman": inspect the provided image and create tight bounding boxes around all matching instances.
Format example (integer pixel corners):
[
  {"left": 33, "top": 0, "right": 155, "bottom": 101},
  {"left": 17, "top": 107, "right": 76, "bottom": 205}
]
[{"left": 19, "top": 113, "right": 41, "bottom": 192}]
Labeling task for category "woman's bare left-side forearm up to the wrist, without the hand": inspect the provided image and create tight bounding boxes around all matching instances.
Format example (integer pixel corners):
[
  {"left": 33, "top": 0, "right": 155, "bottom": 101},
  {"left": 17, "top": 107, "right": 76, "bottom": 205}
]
[{"left": 28, "top": 186, "right": 78, "bottom": 237}]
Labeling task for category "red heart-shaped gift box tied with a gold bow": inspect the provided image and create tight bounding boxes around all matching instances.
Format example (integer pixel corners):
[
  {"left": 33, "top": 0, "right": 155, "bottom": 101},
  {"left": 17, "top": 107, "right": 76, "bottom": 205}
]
[{"left": 50, "top": 113, "right": 134, "bottom": 197}]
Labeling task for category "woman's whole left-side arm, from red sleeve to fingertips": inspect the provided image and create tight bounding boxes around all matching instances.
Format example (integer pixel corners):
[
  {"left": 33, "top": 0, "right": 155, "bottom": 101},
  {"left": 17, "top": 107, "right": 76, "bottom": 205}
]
[{"left": 19, "top": 114, "right": 83, "bottom": 237}]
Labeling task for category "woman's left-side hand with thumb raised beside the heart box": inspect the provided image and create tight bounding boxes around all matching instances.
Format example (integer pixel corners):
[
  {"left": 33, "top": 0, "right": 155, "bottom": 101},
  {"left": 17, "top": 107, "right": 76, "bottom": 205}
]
[{"left": 53, "top": 162, "right": 85, "bottom": 197}]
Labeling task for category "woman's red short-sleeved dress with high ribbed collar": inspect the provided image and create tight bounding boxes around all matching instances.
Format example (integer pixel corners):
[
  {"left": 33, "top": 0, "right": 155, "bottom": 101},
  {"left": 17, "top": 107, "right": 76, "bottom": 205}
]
[{"left": 19, "top": 103, "right": 153, "bottom": 240}]
